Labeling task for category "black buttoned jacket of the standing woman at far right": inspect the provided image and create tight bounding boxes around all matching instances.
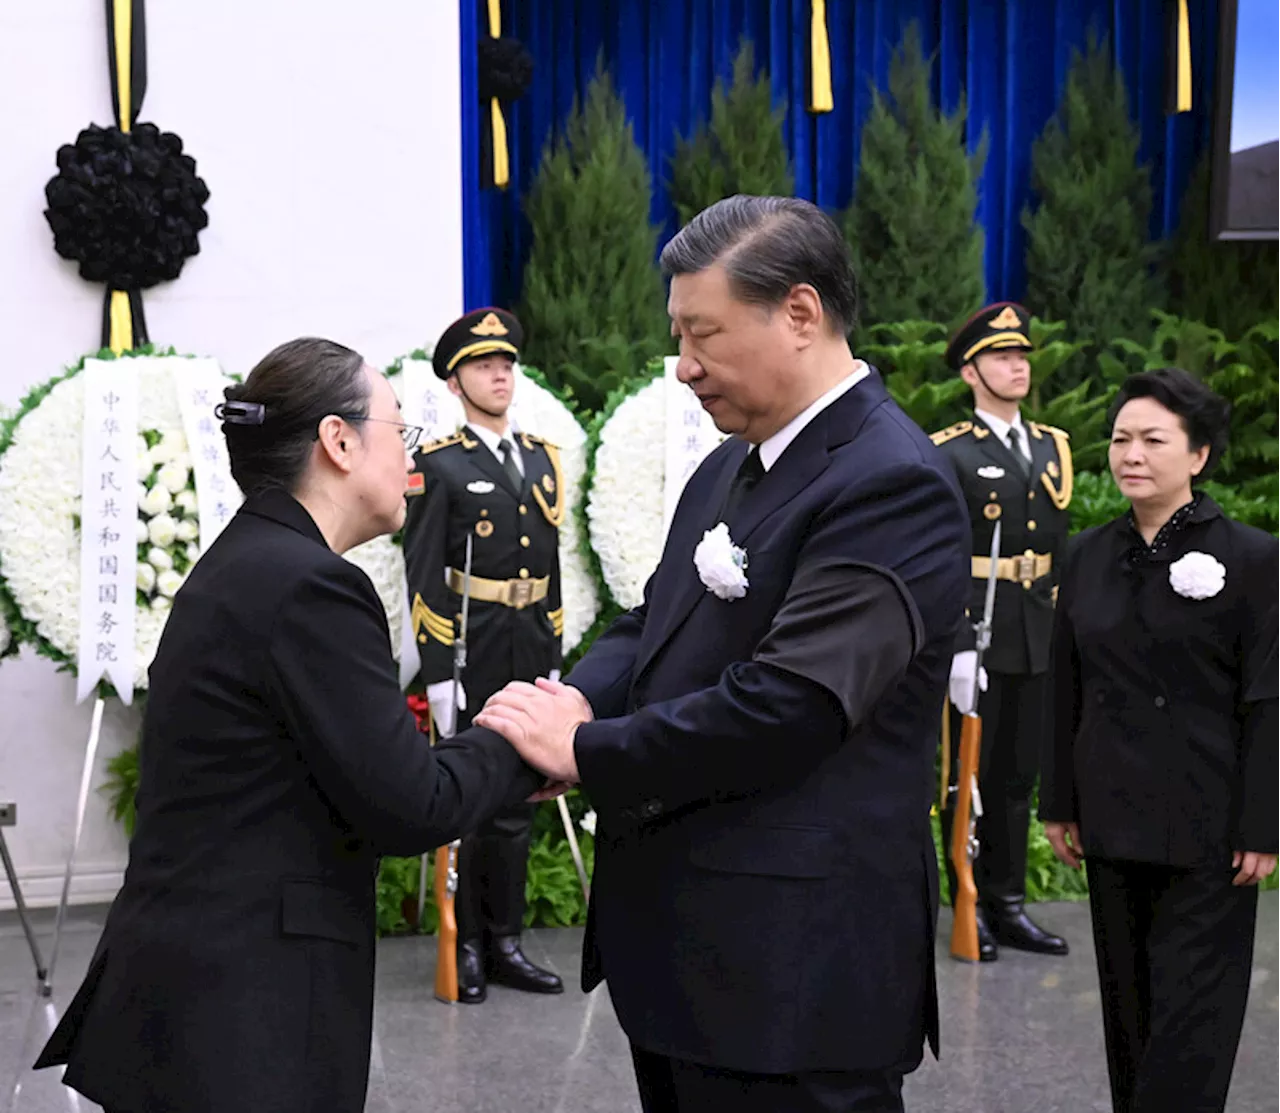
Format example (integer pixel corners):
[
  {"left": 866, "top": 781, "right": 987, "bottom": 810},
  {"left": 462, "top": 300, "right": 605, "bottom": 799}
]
[{"left": 1039, "top": 498, "right": 1280, "bottom": 869}]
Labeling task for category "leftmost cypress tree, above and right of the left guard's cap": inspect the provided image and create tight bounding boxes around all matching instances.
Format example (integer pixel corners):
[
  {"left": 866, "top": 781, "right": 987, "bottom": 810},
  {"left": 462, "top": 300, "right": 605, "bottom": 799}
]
[{"left": 518, "top": 61, "right": 671, "bottom": 411}]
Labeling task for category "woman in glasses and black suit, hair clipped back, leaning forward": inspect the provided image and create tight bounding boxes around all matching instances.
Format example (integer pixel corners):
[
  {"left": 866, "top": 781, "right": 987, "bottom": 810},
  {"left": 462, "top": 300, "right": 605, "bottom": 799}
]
[{"left": 36, "top": 339, "right": 543, "bottom": 1113}]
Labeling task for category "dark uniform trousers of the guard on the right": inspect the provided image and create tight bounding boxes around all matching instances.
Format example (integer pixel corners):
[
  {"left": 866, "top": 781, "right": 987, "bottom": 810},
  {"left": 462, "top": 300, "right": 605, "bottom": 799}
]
[{"left": 942, "top": 673, "right": 1050, "bottom": 910}]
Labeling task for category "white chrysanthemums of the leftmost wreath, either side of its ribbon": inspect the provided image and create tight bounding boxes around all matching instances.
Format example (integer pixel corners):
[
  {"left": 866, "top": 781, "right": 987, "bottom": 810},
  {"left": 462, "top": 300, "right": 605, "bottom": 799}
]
[{"left": 0, "top": 358, "right": 238, "bottom": 688}]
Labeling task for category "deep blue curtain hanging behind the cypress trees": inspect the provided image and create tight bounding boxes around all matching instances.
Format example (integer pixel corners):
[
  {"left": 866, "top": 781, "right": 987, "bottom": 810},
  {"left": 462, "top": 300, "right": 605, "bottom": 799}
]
[{"left": 461, "top": 0, "right": 1217, "bottom": 313}]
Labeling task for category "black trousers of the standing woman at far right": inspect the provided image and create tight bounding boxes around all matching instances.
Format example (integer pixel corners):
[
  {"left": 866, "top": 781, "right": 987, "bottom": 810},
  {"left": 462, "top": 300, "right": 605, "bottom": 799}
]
[{"left": 1087, "top": 858, "right": 1258, "bottom": 1113}]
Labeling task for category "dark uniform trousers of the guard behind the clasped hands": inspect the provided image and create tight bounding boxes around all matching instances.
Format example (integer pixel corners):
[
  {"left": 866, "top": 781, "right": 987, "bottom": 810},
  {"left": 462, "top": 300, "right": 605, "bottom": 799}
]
[{"left": 454, "top": 674, "right": 534, "bottom": 945}]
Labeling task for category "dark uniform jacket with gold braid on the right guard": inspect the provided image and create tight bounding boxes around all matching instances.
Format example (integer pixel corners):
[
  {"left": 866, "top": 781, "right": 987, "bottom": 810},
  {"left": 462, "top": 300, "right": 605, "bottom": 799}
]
[{"left": 933, "top": 414, "right": 1074, "bottom": 675}]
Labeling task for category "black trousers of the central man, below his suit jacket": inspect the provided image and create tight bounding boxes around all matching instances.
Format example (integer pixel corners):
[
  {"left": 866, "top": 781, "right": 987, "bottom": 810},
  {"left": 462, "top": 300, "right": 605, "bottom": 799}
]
[{"left": 631, "top": 1044, "right": 904, "bottom": 1113}]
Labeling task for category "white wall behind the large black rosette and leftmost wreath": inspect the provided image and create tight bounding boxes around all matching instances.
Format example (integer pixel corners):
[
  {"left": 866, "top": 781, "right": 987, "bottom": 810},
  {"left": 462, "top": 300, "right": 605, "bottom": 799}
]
[{"left": 0, "top": 0, "right": 463, "bottom": 907}]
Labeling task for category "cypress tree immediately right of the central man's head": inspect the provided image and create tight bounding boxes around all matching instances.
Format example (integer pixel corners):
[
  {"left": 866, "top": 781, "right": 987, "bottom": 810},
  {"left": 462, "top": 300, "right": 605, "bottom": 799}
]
[{"left": 844, "top": 22, "right": 987, "bottom": 325}]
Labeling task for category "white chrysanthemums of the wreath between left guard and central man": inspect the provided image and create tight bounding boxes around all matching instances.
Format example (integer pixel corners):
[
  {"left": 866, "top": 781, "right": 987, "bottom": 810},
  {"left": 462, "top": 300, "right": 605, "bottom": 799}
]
[{"left": 586, "top": 379, "right": 667, "bottom": 609}]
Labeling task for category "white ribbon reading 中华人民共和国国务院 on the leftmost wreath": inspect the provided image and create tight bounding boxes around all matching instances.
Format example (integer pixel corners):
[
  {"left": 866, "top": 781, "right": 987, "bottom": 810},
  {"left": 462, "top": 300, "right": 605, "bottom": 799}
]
[{"left": 76, "top": 359, "right": 138, "bottom": 704}]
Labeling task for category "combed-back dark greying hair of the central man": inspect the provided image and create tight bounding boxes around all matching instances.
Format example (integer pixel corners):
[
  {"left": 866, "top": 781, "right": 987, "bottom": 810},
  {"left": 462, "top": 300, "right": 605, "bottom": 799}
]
[{"left": 660, "top": 193, "right": 858, "bottom": 335}]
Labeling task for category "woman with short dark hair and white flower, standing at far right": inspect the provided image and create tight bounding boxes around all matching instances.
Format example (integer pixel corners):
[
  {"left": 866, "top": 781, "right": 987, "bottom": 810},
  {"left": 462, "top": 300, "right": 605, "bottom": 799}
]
[{"left": 1039, "top": 370, "right": 1280, "bottom": 1113}]
